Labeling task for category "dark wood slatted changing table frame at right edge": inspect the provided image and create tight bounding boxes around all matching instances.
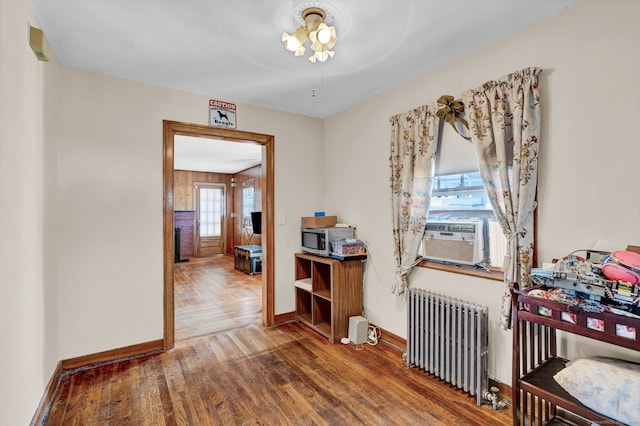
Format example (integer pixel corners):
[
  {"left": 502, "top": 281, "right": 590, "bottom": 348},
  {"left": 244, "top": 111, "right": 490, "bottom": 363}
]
[{"left": 512, "top": 286, "right": 640, "bottom": 425}]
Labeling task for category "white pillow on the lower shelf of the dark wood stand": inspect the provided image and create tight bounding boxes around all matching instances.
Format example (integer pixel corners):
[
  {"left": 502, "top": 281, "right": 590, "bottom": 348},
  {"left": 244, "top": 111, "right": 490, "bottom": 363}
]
[{"left": 553, "top": 357, "right": 640, "bottom": 424}]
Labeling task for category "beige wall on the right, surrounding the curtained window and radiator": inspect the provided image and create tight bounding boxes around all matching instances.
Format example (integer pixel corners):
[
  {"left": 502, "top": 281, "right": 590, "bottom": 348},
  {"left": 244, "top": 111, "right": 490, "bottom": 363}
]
[{"left": 325, "top": 0, "right": 640, "bottom": 383}]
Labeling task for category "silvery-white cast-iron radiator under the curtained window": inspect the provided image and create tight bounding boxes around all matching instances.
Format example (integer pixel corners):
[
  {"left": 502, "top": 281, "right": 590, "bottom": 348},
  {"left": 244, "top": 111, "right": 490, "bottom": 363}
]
[{"left": 405, "top": 289, "right": 489, "bottom": 405}]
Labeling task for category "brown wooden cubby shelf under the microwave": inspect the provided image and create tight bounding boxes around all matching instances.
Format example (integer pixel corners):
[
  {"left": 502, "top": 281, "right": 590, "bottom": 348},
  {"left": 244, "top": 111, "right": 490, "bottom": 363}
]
[{"left": 295, "top": 253, "right": 362, "bottom": 343}]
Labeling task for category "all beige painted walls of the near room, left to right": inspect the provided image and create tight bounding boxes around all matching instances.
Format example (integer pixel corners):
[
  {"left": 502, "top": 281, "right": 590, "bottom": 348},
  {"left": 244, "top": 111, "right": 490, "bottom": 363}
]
[{"left": 0, "top": 0, "right": 640, "bottom": 424}]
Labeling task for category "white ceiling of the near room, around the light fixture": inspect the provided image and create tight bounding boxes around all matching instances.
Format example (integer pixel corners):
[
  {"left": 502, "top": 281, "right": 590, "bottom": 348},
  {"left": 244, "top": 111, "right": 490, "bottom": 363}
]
[{"left": 33, "top": 0, "right": 577, "bottom": 173}]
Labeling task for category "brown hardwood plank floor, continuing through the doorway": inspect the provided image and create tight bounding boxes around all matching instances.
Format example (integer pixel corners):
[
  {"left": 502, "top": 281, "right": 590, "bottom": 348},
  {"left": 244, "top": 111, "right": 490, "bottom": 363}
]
[{"left": 44, "top": 258, "right": 511, "bottom": 426}]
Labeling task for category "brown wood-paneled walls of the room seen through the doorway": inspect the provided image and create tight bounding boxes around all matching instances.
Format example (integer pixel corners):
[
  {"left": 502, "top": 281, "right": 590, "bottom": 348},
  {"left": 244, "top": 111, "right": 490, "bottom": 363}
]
[{"left": 173, "top": 166, "right": 262, "bottom": 254}]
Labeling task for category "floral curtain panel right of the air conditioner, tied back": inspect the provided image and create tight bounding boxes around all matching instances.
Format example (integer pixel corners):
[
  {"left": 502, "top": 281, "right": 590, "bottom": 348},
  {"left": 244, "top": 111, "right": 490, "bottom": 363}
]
[{"left": 462, "top": 68, "right": 542, "bottom": 329}]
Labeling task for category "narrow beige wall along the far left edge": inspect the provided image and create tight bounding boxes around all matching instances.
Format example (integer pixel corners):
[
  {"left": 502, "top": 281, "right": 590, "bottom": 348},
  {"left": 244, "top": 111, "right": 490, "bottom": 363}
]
[{"left": 0, "top": 0, "right": 59, "bottom": 425}]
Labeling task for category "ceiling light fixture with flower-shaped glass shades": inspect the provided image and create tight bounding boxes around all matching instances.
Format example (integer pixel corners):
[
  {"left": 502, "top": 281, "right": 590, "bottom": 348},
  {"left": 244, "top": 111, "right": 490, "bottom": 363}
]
[{"left": 282, "top": 7, "right": 336, "bottom": 62}]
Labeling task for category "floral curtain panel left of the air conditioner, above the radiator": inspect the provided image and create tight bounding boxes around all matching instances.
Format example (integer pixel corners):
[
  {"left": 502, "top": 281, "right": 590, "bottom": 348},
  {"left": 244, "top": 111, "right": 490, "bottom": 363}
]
[{"left": 389, "top": 102, "right": 440, "bottom": 294}]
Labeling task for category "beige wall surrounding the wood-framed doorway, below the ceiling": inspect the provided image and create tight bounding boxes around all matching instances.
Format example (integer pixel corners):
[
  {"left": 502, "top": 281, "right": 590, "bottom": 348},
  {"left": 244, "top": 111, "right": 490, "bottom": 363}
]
[{"left": 58, "top": 69, "right": 324, "bottom": 359}]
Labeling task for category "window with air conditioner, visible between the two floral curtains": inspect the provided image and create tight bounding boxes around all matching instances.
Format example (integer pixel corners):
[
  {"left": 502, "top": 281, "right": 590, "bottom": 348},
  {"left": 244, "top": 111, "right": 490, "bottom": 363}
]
[{"left": 420, "top": 125, "right": 506, "bottom": 279}]
